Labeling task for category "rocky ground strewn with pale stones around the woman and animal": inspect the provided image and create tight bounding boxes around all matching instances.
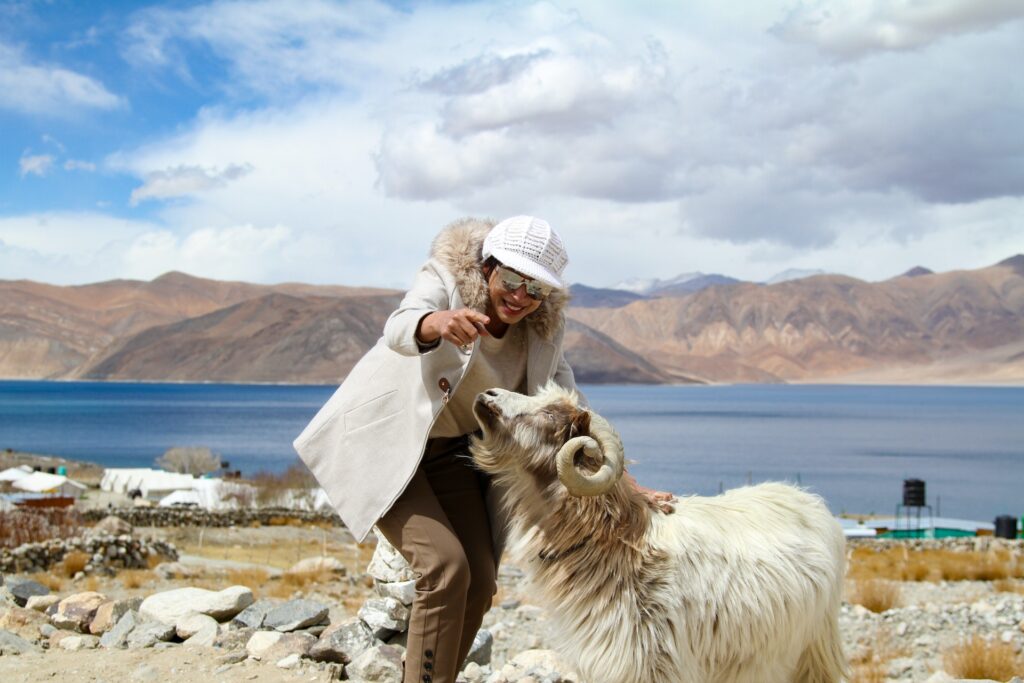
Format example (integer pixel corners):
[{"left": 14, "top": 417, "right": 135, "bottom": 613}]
[{"left": 0, "top": 520, "right": 1024, "bottom": 683}]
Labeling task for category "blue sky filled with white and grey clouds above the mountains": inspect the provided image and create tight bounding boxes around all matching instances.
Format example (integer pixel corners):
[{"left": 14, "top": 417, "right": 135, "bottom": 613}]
[{"left": 0, "top": 0, "right": 1024, "bottom": 288}]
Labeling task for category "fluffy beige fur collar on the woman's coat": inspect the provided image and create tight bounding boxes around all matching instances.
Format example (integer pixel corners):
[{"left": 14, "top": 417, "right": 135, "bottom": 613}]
[{"left": 430, "top": 218, "right": 569, "bottom": 341}]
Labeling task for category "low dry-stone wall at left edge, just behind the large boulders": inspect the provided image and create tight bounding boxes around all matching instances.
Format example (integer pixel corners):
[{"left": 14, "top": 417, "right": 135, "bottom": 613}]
[{"left": 0, "top": 536, "right": 178, "bottom": 573}]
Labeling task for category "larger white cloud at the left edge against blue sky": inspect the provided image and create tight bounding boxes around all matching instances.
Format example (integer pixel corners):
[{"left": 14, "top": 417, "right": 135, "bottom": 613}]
[{"left": 0, "top": 41, "right": 124, "bottom": 118}]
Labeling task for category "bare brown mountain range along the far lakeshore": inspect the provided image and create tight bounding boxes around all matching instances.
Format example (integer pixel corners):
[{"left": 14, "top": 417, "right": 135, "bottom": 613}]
[{"left": 0, "top": 256, "right": 1024, "bottom": 383}]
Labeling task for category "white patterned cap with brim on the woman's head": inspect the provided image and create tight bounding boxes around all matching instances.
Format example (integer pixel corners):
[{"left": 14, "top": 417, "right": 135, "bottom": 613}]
[{"left": 483, "top": 216, "right": 569, "bottom": 289}]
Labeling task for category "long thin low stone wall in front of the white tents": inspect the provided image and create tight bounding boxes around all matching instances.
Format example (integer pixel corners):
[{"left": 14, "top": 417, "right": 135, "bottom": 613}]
[{"left": 82, "top": 508, "right": 341, "bottom": 526}]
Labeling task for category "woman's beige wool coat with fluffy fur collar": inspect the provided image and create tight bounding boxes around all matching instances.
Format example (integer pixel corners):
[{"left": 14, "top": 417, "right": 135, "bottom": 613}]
[{"left": 294, "top": 218, "right": 575, "bottom": 541}]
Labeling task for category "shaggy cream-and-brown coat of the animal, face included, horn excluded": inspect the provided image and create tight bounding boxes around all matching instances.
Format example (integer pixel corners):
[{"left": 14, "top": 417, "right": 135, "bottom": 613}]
[{"left": 471, "top": 386, "right": 846, "bottom": 683}]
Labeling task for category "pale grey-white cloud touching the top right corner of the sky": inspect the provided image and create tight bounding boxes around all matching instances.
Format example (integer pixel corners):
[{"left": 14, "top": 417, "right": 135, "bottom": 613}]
[{"left": 773, "top": 0, "right": 1024, "bottom": 57}]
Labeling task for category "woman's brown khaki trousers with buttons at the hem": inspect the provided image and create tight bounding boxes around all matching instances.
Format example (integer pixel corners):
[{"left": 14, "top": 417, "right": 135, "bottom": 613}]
[{"left": 377, "top": 437, "right": 498, "bottom": 683}]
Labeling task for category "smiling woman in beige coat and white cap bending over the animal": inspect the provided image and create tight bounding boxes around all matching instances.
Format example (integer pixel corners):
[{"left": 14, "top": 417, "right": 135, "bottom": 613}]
[{"left": 295, "top": 216, "right": 663, "bottom": 683}]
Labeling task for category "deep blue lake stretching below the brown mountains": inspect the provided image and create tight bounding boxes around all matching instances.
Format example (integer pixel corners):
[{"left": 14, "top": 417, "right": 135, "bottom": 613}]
[{"left": 0, "top": 381, "right": 1024, "bottom": 521}]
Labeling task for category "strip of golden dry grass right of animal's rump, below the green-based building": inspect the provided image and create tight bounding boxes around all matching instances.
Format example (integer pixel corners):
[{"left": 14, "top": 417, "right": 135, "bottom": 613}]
[{"left": 847, "top": 546, "right": 1024, "bottom": 582}]
